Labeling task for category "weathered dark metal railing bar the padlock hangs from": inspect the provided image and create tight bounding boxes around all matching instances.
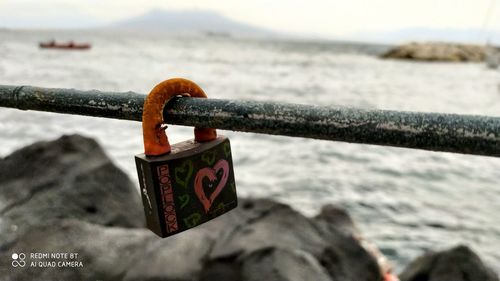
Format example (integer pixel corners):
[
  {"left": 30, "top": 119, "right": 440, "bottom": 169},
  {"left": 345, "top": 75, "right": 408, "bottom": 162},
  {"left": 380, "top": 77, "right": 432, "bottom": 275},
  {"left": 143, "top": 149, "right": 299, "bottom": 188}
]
[{"left": 0, "top": 85, "right": 500, "bottom": 157}]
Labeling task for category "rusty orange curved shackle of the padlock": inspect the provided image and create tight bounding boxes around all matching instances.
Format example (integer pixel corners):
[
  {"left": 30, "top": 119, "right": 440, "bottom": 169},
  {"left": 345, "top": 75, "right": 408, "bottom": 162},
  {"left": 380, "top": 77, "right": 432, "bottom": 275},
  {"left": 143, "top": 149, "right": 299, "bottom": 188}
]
[{"left": 142, "top": 78, "right": 217, "bottom": 156}]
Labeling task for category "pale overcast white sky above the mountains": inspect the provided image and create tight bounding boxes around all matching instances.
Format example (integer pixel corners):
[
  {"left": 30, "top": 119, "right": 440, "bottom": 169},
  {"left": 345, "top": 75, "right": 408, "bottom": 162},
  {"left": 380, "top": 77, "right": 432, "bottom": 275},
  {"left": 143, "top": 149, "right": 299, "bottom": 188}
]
[{"left": 0, "top": 0, "right": 500, "bottom": 41}]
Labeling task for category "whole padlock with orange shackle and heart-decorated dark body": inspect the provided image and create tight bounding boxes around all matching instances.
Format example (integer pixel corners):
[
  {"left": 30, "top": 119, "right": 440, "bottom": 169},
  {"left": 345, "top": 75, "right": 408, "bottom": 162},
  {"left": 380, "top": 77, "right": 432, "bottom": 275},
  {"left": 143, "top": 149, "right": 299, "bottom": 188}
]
[{"left": 135, "top": 78, "right": 238, "bottom": 237}]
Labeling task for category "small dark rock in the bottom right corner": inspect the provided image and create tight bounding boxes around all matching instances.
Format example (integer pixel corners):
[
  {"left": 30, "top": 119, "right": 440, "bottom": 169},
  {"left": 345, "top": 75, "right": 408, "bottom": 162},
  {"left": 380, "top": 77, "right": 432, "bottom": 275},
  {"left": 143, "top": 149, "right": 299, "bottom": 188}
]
[{"left": 399, "top": 246, "right": 499, "bottom": 281}]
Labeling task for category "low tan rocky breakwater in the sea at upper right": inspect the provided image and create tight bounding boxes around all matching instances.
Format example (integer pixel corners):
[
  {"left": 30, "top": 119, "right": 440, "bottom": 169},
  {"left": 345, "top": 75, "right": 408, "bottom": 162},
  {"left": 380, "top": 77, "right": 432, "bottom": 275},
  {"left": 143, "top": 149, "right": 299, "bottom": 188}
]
[{"left": 381, "top": 42, "right": 492, "bottom": 62}]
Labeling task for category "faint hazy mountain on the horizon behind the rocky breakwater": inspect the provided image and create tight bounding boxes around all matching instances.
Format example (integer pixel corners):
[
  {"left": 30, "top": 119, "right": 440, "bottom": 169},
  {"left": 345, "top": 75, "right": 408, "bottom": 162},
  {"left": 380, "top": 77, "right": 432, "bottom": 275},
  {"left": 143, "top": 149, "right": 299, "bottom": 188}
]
[{"left": 353, "top": 27, "right": 500, "bottom": 45}]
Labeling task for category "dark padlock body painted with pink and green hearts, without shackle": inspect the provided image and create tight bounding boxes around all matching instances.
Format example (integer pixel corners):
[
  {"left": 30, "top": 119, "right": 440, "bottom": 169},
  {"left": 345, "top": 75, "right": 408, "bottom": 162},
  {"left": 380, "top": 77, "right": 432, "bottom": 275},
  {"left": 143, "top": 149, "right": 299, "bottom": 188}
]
[{"left": 135, "top": 136, "right": 237, "bottom": 237}]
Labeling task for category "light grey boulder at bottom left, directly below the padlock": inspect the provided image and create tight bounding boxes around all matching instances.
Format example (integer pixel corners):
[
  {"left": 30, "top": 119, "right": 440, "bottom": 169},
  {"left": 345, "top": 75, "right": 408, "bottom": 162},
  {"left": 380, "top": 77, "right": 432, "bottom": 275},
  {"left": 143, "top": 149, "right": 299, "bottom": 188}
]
[{"left": 0, "top": 219, "right": 215, "bottom": 281}]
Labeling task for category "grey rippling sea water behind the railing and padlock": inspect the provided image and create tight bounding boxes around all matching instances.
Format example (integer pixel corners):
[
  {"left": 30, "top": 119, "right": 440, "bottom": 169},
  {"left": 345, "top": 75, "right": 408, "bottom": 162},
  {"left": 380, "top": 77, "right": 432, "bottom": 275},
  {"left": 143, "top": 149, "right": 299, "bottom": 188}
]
[{"left": 0, "top": 30, "right": 500, "bottom": 270}]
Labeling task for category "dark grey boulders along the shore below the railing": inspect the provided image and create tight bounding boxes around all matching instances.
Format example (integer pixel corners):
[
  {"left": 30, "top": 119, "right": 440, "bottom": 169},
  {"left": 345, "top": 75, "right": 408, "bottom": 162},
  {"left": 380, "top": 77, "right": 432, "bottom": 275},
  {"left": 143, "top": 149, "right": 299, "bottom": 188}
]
[{"left": 0, "top": 135, "right": 499, "bottom": 281}]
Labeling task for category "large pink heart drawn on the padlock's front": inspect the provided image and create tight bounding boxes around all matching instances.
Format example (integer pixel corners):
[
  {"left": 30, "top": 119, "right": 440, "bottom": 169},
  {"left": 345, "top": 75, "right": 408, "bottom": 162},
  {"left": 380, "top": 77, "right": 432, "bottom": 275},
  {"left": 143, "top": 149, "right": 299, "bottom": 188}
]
[{"left": 194, "top": 159, "right": 229, "bottom": 213}]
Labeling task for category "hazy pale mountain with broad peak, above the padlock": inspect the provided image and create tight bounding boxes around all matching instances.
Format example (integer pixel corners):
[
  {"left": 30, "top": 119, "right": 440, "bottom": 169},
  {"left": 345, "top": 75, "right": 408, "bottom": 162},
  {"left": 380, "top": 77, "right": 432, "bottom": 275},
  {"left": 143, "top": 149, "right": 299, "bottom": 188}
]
[{"left": 109, "top": 9, "right": 278, "bottom": 37}]
